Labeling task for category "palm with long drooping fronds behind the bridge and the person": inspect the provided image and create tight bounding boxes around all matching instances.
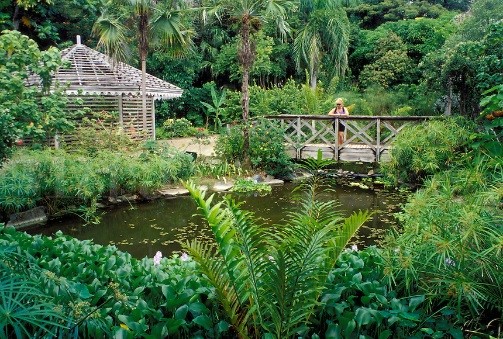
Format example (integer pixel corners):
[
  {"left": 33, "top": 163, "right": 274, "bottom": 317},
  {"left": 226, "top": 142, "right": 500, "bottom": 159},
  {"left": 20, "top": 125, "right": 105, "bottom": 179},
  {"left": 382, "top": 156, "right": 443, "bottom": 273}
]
[{"left": 293, "top": 0, "right": 349, "bottom": 88}]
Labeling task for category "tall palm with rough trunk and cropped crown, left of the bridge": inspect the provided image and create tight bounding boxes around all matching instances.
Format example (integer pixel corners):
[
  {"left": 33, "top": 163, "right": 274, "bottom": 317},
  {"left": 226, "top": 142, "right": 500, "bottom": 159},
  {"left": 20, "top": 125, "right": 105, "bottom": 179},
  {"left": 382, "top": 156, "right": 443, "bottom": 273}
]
[{"left": 203, "top": 0, "right": 294, "bottom": 166}]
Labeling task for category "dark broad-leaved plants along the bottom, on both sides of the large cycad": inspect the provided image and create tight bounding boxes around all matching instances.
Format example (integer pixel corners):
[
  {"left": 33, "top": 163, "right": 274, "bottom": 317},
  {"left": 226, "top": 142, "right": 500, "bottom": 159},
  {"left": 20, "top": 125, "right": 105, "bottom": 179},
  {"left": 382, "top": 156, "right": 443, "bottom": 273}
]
[{"left": 0, "top": 222, "right": 468, "bottom": 338}]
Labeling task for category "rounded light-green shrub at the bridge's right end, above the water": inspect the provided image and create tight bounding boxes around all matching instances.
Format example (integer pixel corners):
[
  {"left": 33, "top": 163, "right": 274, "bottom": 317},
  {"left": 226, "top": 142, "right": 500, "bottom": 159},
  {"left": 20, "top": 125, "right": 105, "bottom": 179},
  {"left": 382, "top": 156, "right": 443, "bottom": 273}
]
[{"left": 381, "top": 118, "right": 475, "bottom": 184}]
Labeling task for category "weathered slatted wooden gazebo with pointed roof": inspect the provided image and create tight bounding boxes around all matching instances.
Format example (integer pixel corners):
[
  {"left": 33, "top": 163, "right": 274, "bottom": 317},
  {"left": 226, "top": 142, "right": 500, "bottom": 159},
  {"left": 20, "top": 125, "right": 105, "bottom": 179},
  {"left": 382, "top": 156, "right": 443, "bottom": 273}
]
[{"left": 30, "top": 36, "right": 183, "bottom": 143}]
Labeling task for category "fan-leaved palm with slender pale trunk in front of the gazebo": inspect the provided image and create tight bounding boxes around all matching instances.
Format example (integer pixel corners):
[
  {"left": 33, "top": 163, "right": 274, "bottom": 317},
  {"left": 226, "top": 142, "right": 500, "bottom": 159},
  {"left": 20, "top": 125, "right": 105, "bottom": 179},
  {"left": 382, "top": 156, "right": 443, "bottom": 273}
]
[{"left": 93, "top": 0, "right": 192, "bottom": 137}]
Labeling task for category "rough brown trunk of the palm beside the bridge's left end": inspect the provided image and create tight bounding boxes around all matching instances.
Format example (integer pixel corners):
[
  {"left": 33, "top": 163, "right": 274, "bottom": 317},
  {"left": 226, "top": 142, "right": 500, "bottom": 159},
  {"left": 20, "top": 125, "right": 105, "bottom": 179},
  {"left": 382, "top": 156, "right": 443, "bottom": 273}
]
[{"left": 239, "top": 14, "right": 255, "bottom": 167}]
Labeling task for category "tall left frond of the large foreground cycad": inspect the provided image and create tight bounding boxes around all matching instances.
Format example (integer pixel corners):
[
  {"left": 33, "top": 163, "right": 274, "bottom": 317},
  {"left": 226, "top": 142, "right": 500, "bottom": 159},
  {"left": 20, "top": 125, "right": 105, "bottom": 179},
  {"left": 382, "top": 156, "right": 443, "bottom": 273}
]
[{"left": 185, "top": 183, "right": 270, "bottom": 333}]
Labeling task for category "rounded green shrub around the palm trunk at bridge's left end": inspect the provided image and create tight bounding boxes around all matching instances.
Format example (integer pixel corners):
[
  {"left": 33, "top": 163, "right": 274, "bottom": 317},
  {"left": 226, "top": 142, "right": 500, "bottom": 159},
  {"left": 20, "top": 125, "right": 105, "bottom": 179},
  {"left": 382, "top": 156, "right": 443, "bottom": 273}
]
[{"left": 215, "top": 119, "right": 293, "bottom": 177}]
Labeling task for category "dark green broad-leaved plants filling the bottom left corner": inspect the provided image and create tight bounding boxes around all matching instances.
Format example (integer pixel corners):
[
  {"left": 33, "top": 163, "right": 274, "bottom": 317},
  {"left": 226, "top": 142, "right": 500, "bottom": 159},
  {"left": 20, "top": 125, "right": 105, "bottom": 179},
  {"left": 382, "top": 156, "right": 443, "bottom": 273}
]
[{"left": 0, "top": 225, "right": 219, "bottom": 338}]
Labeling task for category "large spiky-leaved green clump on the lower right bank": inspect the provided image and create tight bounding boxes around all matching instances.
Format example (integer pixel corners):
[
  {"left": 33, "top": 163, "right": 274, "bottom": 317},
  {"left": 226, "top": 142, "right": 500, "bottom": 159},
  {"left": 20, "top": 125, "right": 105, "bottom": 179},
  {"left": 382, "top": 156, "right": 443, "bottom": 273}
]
[{"left": 383, "top": 161, "right": 503, "bottom": 335}]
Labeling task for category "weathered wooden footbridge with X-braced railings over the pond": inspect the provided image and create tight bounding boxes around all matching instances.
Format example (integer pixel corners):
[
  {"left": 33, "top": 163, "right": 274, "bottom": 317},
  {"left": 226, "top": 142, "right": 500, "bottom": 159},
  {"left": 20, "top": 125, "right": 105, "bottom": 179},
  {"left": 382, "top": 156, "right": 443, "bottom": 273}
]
[{"left": 266, "top": 114, "right": 438, "bottom": 162}]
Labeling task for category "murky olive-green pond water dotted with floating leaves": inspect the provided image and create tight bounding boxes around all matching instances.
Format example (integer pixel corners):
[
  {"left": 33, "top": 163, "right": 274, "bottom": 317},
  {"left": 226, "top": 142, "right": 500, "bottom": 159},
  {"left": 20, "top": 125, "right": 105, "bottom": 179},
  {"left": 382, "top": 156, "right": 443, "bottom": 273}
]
[{"left": 29, "top": 183, "right": 405, "bottom": 258}]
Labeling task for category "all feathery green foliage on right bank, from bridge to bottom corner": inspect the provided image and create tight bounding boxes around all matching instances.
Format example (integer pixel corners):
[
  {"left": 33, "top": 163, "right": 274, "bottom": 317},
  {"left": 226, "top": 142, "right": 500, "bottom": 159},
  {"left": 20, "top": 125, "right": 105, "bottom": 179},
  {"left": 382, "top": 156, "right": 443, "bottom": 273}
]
[{"left": 383, "top": 99, "right": 503, "bottom": 335}]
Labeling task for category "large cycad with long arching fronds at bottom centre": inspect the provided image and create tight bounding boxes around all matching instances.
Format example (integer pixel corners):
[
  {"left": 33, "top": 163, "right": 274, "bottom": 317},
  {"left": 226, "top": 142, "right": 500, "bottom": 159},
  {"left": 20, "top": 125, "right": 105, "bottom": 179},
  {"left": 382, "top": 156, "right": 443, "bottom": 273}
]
[{"left": 184, "top": 162, "right": 367, "bottom": 338}]
